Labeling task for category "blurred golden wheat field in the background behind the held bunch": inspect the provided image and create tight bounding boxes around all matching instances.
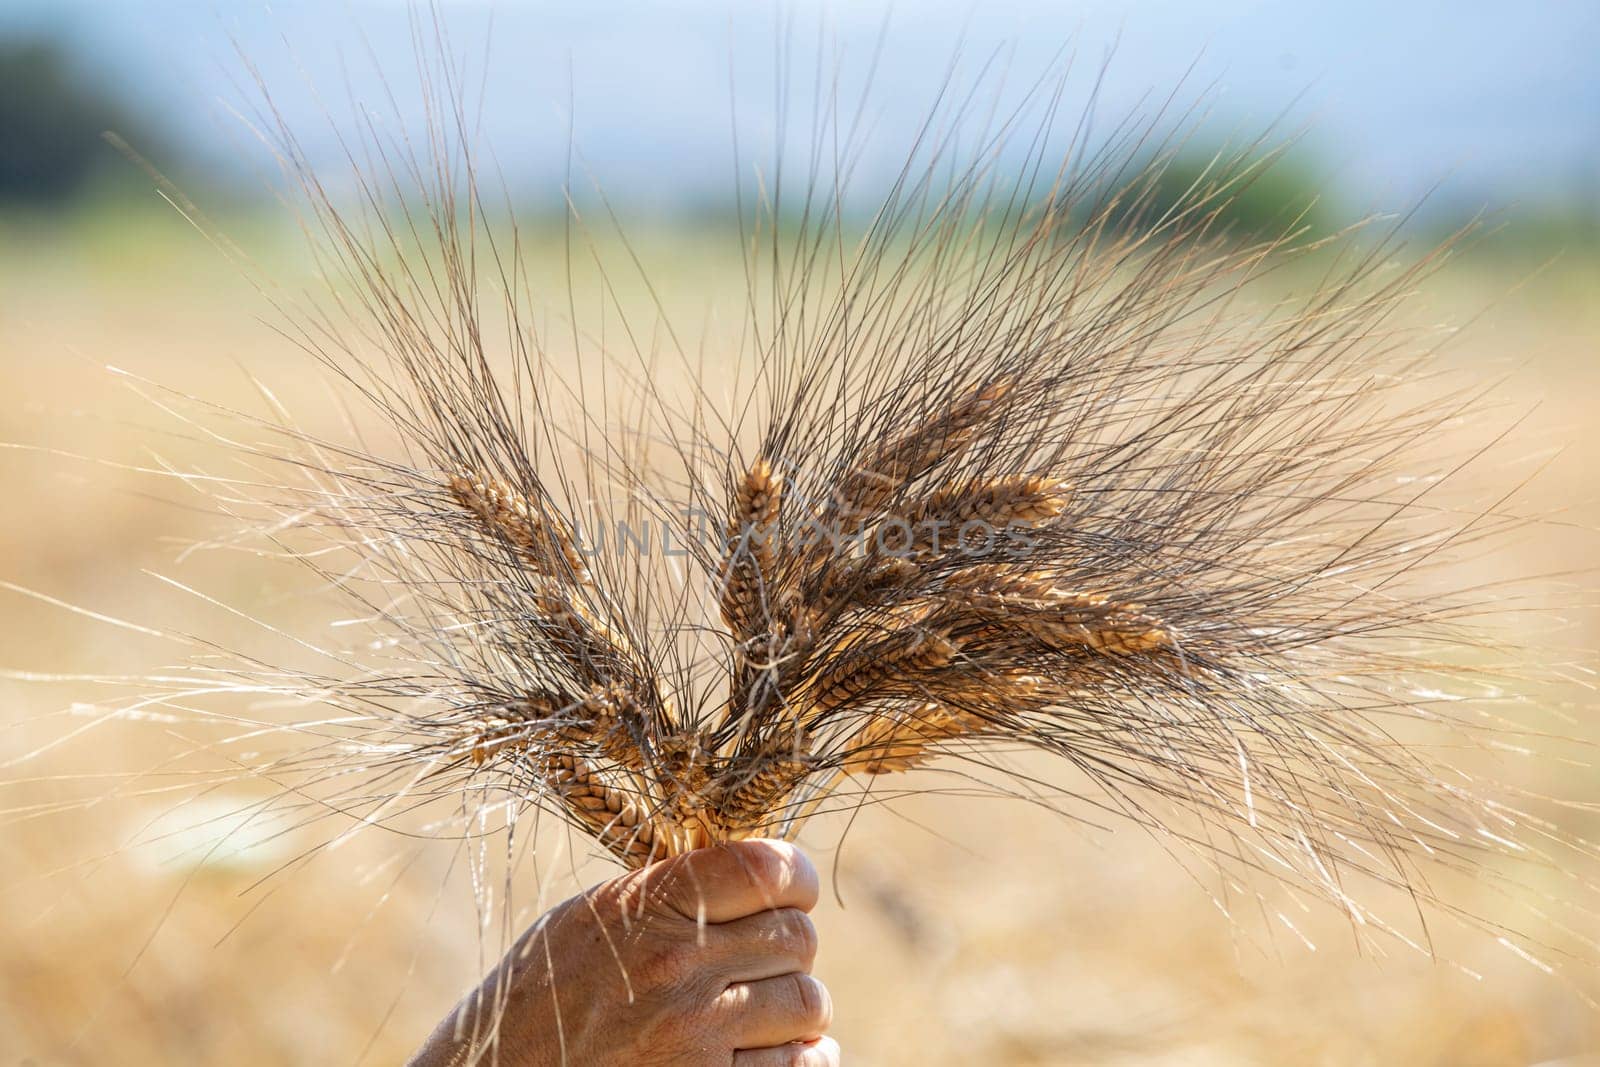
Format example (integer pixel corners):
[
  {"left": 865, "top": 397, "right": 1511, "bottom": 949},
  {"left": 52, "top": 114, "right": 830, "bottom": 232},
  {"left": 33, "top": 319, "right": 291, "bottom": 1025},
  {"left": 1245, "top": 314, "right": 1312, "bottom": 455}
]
[{"left": 0, "top": 216, "right": 1600, "bottom": 1065}]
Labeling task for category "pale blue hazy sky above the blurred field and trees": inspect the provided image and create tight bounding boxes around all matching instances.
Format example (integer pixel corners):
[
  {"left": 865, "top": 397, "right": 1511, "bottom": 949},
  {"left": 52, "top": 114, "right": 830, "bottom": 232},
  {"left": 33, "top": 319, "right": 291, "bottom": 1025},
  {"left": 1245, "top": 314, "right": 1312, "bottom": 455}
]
[{"left": 0, "top": 0, "right": 1600, "bottom": 219}]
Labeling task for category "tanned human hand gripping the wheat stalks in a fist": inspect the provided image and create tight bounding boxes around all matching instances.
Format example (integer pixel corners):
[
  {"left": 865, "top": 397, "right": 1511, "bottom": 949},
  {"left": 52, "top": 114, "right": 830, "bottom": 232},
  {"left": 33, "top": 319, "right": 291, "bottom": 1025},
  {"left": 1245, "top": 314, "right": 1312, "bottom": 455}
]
[{"left": 411, "top": 840, "right": 838, "bottom": 1067}]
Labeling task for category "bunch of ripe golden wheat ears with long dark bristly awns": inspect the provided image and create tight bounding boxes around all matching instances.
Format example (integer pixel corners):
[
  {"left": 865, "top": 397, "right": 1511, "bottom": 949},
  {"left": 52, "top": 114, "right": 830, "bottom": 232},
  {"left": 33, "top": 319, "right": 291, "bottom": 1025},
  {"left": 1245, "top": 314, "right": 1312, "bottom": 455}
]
[{"left": 100, "top": 35, "right": 1589, "bottom": 1004}]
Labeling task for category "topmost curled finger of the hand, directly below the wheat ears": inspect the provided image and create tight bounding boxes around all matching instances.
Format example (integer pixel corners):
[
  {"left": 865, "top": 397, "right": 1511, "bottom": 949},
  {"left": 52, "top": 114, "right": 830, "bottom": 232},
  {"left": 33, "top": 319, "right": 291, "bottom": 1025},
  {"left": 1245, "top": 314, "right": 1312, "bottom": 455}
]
[{"left": 640, "top": 840, "right": 819, "bottom": 923}]
